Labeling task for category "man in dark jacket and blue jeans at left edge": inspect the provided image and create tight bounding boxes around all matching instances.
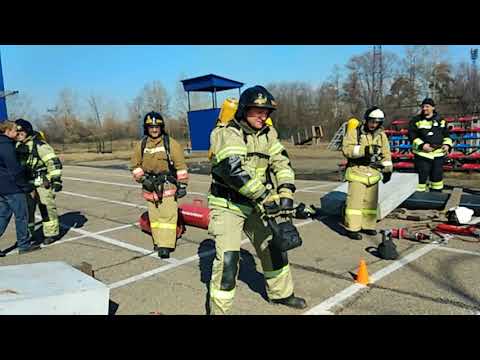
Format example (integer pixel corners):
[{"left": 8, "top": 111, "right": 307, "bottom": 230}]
[{"left": 0, "top": 121, "right": 40, "bottom": 256}]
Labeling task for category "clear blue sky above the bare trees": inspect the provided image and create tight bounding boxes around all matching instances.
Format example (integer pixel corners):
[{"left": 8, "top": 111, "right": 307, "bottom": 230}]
[{"left": 0, "top": 45, "right": 480, "bottom": 116}]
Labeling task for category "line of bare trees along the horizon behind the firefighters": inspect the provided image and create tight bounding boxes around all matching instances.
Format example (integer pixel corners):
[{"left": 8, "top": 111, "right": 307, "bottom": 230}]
[{"left": 7, "top": 46, "right": 479, "bottom": 144}]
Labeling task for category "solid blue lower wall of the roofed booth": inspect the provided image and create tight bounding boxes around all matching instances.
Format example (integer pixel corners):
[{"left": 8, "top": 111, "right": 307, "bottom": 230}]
[{"left": 188, "top": 109, "right": 220, "bottom": 151}]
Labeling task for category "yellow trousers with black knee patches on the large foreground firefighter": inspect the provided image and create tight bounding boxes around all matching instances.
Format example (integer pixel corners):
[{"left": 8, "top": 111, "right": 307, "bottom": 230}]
[{"left": 208, "top": 208, "right": 293, "bottom": 315}]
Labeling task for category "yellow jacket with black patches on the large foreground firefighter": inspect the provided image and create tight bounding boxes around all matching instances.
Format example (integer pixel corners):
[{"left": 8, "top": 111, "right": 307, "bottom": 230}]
[{"left": 208, "top": 119, "right": 295, "bottom": 216}]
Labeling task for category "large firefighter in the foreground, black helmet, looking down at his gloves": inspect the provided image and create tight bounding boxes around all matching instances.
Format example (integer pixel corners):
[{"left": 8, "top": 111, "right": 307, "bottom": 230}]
[{"left": 208, "top": 85, "right": 306, "bottom": 315}]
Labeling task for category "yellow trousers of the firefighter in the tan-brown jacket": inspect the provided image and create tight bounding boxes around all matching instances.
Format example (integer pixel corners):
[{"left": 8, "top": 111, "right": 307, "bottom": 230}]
[{"left": 148, "top": 196, "right": 178, "bottom": 249}]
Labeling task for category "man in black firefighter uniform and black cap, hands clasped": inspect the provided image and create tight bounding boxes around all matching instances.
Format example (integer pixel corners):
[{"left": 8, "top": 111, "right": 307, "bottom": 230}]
[{"left": 408, "top": 98, "right": 453, "bottom": 192}]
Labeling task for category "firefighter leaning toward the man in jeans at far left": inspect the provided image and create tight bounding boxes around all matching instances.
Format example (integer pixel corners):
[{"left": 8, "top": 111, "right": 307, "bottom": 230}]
[{"left": 15, "top": 119, "right": 63, "bottom": 245}]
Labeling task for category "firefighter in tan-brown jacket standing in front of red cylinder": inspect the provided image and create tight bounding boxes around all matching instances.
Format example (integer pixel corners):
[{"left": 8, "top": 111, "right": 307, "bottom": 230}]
[{"left": 130, "top": 111, "right": 188, "bottom": 258}]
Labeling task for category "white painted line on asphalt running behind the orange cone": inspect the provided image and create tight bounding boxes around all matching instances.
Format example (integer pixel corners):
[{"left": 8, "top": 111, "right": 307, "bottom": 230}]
[{"left": 303, "top": 244, "right": 440, "bottom": 315}]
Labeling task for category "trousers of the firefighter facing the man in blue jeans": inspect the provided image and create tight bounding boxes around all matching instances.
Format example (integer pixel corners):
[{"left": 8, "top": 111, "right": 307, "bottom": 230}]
[{"left": 27, "top": 186, "right": 60, "bottom": 237}]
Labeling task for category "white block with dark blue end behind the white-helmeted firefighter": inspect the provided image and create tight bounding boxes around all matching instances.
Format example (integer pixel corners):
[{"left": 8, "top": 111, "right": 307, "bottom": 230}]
[{"left": 320, "top": 173, "right": 418, "bottom": 219}]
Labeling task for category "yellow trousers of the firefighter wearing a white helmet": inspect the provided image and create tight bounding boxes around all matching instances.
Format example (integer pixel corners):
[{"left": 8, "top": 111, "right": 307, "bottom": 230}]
[{"left": 345, "top": 181, "right": 378, "bottom": 231}]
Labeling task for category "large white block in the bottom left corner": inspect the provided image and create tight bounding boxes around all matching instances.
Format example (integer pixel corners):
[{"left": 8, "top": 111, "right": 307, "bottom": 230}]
[{"left": 0, "top": 261, "right": 110, "bottom": 315}]
